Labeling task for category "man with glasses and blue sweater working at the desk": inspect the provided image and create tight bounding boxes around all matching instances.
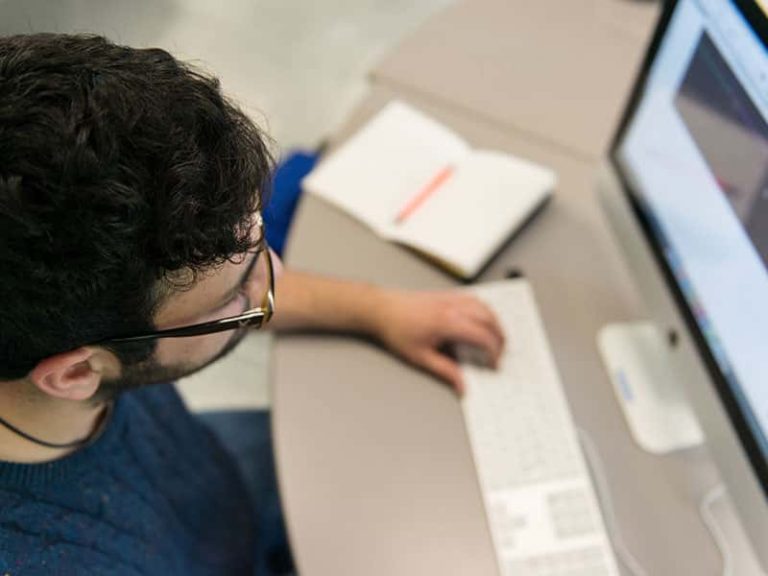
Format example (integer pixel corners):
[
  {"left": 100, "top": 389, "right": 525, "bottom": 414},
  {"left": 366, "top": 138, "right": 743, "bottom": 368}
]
[{"left": 0, "top": 35, "right": 503, "bottom": 575}]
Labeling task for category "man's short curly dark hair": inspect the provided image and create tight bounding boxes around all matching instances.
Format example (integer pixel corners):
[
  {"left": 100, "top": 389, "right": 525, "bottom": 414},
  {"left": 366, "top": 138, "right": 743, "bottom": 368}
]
[{"left": 0, "top": 34, "right": 272, "bottom": 380}]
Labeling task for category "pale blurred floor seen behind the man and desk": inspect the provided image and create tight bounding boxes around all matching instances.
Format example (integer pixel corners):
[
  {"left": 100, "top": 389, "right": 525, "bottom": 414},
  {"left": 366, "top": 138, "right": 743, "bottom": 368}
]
[{"left": 0, "top": 0, "right": 453, "bottom": 410}]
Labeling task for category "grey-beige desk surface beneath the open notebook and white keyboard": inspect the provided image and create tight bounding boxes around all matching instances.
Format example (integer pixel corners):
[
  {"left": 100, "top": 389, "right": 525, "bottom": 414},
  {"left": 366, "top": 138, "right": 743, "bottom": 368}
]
[{"left": 273, "top": 86, "right": 721, "bottom": 576}]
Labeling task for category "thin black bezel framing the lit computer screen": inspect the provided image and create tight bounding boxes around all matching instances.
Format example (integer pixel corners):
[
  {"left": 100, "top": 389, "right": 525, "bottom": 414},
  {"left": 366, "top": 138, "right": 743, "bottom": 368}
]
[{"left": 608, "top": 0, "right": 768, "bottom": 499}]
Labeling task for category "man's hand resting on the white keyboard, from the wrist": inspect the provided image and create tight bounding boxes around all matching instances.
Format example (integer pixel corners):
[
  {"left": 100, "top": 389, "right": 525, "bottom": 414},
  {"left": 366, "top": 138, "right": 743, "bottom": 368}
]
[{"left": 372, "top": 290, "right": 504, "bottom": 395}]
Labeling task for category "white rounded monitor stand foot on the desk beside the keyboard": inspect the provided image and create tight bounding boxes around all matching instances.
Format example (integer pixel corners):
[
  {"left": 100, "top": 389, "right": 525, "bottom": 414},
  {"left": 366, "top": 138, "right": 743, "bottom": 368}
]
[{"left": 597, "top": 322, "right": 704, "bottom": 454}]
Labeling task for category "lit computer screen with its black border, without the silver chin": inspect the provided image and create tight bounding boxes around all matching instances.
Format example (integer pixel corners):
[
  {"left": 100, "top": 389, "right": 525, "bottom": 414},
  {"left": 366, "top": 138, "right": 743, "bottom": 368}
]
[{"left": 613, "top": 0, "right": 768, "bottom": 486}]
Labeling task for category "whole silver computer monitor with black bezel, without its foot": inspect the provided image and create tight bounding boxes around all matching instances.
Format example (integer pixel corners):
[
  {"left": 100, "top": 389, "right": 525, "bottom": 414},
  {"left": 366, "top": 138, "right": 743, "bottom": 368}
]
[{"left": 598, "top": 0, "right": 768, "bottom": 569}]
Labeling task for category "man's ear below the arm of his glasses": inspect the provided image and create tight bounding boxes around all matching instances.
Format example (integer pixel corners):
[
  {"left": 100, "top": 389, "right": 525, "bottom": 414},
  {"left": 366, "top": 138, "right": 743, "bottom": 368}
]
[{"left": 28, "top": 346, "right": 117, "bottom": 400}]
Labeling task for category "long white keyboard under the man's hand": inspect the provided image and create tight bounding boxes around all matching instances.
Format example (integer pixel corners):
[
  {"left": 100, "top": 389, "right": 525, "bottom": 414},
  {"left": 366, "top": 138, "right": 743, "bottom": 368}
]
[{"left": 459, "top": 280, "right": 619, "bottom": 576}]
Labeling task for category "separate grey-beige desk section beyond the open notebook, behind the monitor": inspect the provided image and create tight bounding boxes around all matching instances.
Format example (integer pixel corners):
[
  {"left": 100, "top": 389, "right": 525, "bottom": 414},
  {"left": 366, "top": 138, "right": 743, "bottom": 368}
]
[{"left": 373, "top": 0, "right": 660, "bottom": 158}]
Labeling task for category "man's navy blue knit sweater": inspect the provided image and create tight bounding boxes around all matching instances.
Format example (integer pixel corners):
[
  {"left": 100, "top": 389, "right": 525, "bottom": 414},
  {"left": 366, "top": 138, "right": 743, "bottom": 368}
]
[{"left": 0, "top": 384, "right": 255, "bottom": 576}]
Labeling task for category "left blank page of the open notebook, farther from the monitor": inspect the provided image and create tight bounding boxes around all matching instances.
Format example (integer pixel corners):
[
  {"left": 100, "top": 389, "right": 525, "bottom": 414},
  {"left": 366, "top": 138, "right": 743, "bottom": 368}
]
[{"left": 302, "top": 101, "right": 469, "bottom": 235}]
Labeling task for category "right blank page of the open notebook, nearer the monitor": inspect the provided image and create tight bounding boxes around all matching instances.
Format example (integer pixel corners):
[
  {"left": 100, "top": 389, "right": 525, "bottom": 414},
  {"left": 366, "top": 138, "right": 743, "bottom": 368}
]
[{"left": 390, "top": 151, "right": 557, "bottom": 276}]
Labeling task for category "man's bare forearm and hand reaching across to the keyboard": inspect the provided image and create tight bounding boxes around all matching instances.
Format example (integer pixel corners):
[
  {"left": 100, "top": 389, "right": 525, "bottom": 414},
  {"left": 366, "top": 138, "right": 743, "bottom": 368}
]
[{"left": 272, "top": 270, "right": 504, "bottom": 393}]
